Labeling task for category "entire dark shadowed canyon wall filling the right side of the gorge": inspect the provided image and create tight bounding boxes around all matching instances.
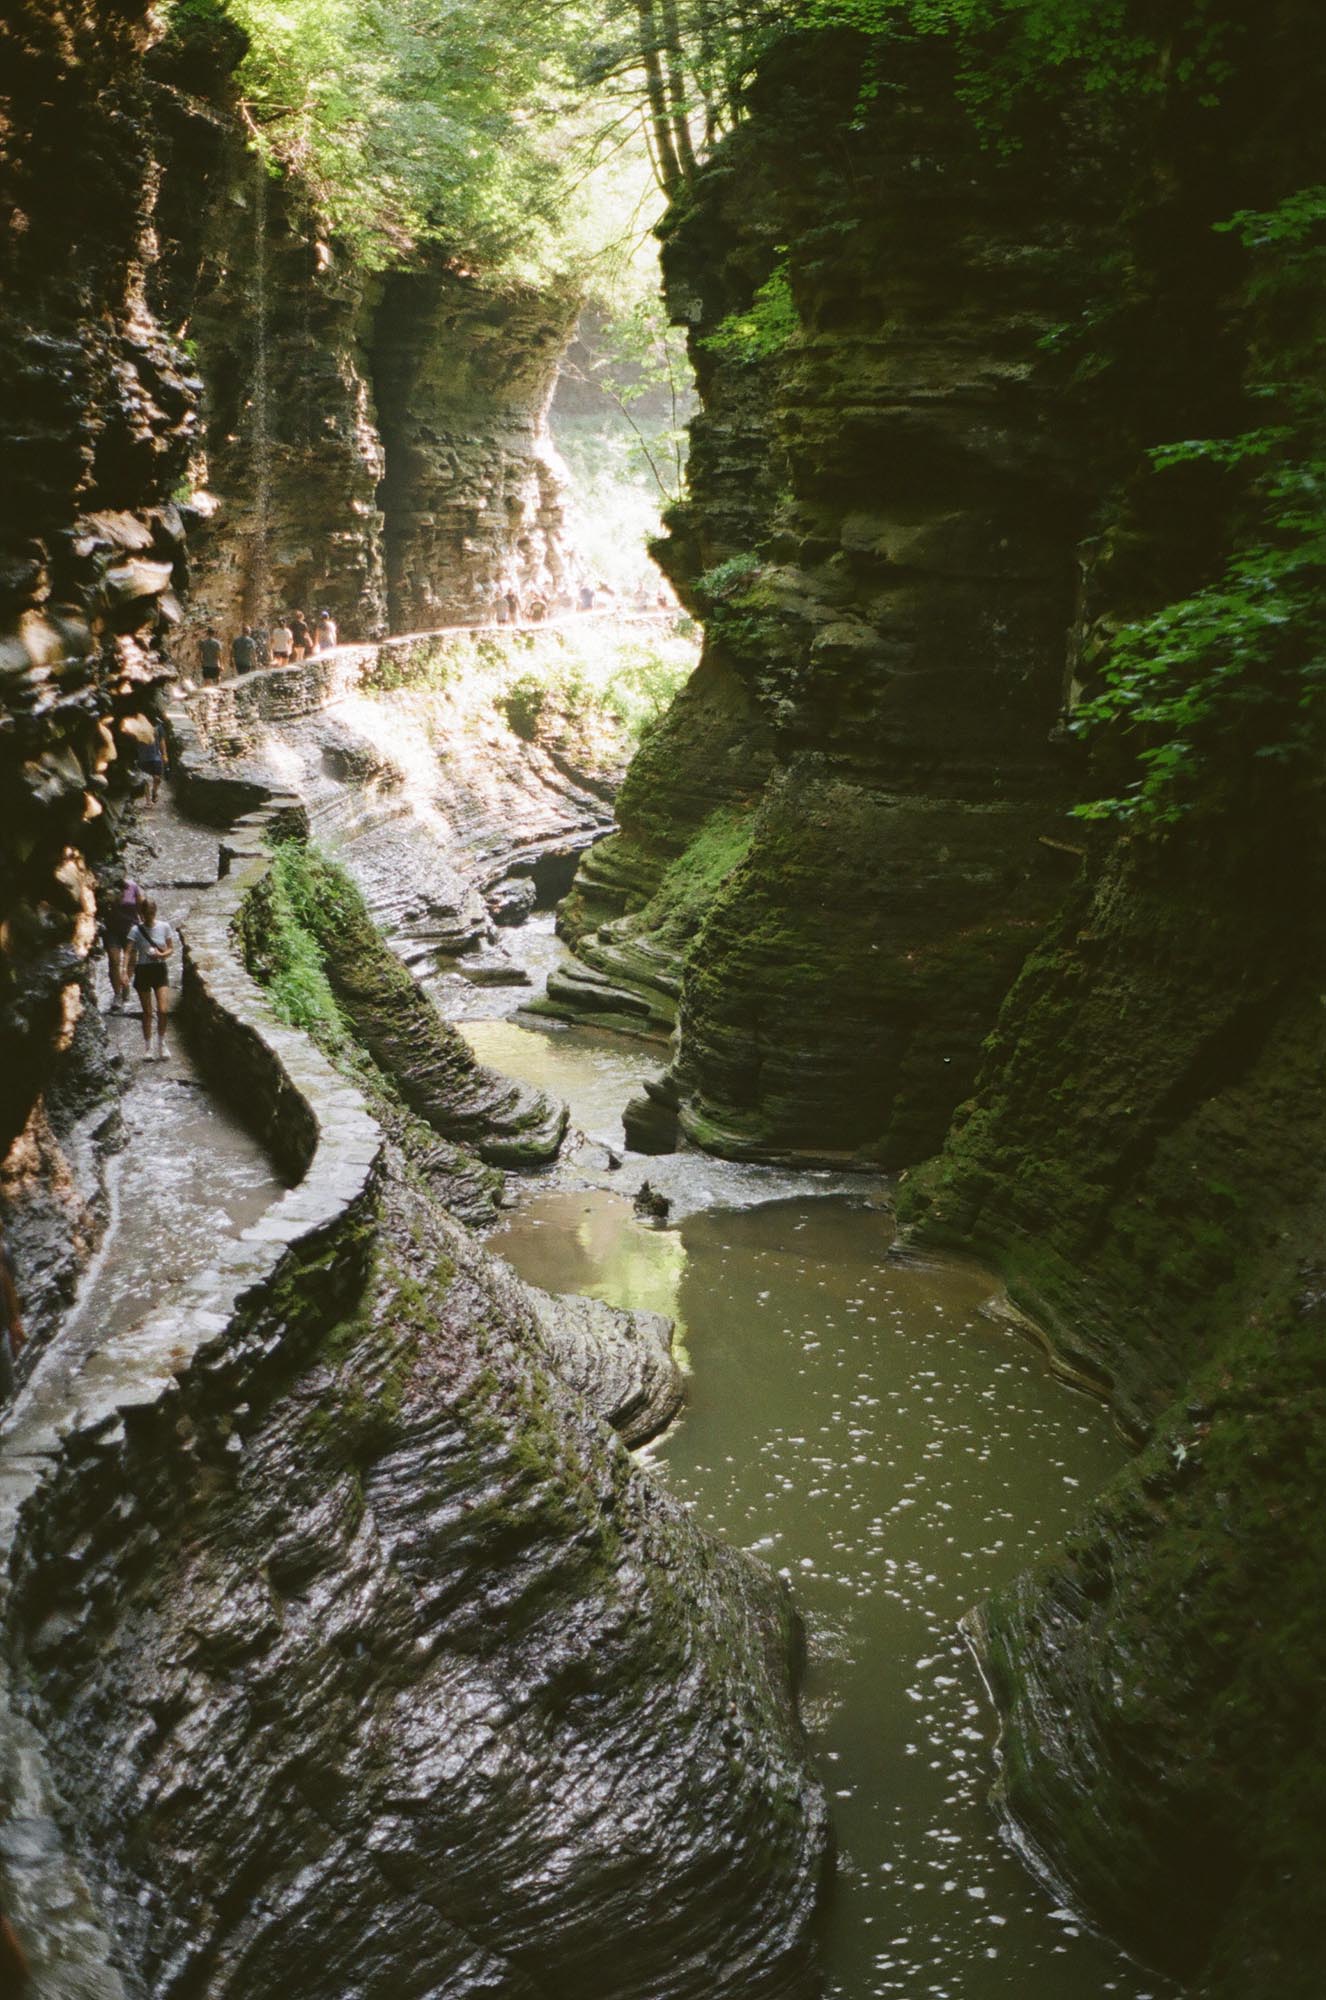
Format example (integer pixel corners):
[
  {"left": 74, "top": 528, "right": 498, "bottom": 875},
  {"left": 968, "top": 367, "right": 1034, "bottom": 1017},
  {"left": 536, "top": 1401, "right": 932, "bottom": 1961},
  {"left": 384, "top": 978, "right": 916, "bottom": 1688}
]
[{"left": 552, "top": 4, "right": 1326, "bottom": 2000}]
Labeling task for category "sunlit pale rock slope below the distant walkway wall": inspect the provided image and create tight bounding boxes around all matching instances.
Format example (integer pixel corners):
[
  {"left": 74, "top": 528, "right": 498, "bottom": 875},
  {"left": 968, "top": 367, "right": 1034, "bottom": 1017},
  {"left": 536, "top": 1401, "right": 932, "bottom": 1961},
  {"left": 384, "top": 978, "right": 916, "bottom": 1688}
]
[{"left": 174, "top": 632, "right": 624, "bottom": 968}]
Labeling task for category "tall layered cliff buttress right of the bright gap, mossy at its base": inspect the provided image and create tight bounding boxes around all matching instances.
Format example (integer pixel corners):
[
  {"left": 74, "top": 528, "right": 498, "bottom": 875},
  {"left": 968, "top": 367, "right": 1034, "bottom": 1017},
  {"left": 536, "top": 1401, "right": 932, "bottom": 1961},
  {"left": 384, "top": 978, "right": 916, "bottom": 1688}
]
[{"left": 554, "top": 38, "right": 1104, "bottom": 1164}]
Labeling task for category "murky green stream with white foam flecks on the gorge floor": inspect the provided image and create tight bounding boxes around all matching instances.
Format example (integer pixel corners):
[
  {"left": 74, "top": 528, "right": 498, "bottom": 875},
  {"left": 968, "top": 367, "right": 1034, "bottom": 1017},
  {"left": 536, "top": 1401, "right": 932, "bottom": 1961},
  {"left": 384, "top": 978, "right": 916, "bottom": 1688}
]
[{"left": 436, "top": 920, "right": 1162, "bottom": 2000}]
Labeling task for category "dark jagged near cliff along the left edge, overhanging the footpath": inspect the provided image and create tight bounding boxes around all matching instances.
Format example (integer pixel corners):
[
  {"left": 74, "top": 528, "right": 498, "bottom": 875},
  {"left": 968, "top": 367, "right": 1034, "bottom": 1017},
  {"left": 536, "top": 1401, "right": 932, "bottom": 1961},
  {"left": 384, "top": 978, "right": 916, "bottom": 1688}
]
[{"left": 0, "top": 0, "right": 200, "bottom": 1332}]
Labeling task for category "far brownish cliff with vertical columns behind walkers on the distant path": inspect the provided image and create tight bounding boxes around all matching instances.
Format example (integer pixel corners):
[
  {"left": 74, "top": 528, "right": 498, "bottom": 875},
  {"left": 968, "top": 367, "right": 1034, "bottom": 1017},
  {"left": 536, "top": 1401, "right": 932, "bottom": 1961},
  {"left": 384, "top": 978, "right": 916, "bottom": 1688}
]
[{"left": 139, "top": 3, "right": 576, "bottom": 652}]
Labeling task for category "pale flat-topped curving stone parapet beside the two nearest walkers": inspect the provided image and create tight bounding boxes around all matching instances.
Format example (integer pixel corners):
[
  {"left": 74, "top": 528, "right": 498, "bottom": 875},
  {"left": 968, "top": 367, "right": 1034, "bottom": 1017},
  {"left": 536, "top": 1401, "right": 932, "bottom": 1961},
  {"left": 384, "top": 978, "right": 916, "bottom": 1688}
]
[{"left": 0, "top": 784, "right": 382, "bottom": 2000}]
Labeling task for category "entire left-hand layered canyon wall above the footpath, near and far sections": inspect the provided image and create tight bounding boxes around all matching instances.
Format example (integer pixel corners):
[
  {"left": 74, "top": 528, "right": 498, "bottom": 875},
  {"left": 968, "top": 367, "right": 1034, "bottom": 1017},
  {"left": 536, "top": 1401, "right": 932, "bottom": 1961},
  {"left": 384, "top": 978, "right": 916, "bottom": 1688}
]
[{"left": 0, "top": 0, "right": 568, "bottom": 1392}]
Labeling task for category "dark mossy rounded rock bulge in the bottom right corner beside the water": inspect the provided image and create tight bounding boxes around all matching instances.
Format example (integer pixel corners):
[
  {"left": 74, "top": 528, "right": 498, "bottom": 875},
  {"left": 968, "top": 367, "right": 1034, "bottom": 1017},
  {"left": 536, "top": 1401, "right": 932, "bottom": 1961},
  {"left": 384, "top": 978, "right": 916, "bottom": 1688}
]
[{"left": 974, "top": 1264, "right": 1326, "bottom": 2000}]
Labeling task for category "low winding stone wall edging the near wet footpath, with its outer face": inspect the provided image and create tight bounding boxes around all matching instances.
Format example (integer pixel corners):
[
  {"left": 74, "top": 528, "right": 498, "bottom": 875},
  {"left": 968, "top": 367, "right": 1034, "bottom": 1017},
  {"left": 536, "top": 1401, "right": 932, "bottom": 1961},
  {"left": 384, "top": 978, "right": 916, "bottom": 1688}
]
[{"left": 0, "top": 784, "right": 382, "bottom": 2000}]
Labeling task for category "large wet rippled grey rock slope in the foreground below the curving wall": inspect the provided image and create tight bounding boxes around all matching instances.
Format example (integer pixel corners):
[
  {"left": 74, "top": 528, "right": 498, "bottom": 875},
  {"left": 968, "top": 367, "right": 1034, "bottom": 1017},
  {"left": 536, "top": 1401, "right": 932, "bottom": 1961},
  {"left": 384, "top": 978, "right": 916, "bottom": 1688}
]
[{"left": 10, "top": 1152, "right": 822, "bottom": 1996}]
